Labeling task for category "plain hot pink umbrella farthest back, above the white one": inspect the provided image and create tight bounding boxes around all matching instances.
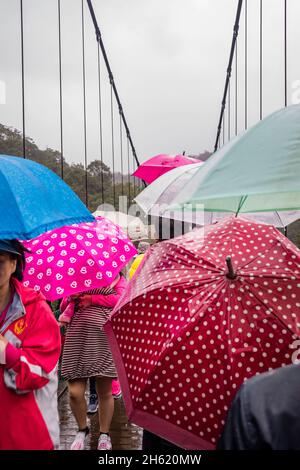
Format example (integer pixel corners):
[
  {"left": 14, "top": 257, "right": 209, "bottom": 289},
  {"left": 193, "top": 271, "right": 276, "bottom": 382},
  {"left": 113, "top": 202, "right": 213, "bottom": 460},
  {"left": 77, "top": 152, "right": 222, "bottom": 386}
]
[{"left": 133, "top": 154, "right": 201, "bottom": 184}]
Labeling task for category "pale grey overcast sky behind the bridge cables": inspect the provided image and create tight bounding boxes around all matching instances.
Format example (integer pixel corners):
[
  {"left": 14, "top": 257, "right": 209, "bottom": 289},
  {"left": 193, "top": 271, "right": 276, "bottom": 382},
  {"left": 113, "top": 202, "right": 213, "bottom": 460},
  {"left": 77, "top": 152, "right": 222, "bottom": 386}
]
[{"left": 0, "top": 0, "right": 300, "bottom": 172}]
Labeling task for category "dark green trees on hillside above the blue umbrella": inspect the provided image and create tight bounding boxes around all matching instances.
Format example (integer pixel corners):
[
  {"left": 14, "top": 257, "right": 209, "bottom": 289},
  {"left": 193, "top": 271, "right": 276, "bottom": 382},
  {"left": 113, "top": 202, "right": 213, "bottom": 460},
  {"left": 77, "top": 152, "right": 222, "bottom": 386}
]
[{"left": 0, "top": 124, "right": 142, "bottom": 212}]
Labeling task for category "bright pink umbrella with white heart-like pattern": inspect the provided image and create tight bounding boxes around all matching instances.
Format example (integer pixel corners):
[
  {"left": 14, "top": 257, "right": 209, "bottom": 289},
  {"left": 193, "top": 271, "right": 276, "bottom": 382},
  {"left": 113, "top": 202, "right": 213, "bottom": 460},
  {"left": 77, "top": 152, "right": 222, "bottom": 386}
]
[{"left": 23, "top": 217, "right": 137, "bottom": 301}]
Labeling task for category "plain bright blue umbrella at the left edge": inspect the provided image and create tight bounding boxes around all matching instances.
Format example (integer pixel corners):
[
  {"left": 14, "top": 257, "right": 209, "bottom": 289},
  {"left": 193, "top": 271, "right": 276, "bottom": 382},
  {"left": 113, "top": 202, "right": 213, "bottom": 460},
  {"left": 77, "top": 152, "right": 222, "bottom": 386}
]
[{"left": 0, "top": 155, "right": 94, "bottom": 240}]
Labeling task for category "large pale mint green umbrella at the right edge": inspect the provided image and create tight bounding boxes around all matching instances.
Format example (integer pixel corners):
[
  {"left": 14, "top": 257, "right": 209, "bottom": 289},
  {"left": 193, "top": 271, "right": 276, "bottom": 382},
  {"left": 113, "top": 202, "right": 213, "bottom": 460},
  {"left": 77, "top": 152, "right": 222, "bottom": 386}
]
[{"left": 167, "top": 105, "right": 300, "bottom": 213}]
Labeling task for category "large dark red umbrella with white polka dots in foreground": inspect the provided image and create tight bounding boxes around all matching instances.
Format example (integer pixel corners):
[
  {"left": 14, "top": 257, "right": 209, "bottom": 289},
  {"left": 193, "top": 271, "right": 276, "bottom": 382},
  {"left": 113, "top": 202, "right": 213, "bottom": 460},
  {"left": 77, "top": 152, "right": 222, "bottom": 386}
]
[{"left": 105, "top": 218, "right": 300, "bottom": 449}]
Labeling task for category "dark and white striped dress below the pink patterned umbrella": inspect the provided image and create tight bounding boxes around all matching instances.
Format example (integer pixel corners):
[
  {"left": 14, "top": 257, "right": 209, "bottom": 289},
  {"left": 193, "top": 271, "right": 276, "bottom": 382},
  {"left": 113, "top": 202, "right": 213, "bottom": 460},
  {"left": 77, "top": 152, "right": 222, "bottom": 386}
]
[{"left": 61, "top": 287, "right": 117, "bottom": 380}]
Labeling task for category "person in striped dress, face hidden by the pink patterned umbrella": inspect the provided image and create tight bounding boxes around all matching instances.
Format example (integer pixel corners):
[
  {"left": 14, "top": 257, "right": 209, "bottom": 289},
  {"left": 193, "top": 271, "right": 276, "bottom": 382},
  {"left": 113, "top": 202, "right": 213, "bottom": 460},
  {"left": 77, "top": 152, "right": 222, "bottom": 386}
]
[{"left": 61, "top": 276, "right": 127, "bottom": 450}]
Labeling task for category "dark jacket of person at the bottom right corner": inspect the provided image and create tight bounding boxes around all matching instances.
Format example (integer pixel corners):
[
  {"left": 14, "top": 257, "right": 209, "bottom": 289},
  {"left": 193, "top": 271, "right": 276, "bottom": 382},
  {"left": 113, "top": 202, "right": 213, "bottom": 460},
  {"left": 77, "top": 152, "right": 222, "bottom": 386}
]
[{"left": 217, "top": 364, "right": 300, "bottom": 450}]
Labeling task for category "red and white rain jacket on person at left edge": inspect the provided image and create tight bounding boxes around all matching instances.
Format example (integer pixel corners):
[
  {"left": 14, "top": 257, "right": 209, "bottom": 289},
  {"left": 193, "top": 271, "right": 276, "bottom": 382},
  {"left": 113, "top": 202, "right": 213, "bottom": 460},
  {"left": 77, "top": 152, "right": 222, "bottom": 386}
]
[{"left": 0, "top": 280, "right": 60, "bottom": 450}]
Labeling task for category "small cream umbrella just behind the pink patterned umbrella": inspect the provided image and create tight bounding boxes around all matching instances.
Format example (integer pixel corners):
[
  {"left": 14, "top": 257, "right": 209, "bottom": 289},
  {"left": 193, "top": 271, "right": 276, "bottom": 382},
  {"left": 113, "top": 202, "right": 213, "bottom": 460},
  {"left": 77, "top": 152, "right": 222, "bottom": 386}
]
[{"left": 93, "top": 210, "right": 147, "bottom": 240}]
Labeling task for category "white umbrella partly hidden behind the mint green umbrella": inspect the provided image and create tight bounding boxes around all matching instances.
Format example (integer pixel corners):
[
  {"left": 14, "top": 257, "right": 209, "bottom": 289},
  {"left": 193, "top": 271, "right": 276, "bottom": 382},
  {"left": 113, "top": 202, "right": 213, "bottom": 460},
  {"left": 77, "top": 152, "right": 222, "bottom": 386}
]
[{"left": 135, "top": 162, "right": 300, "bottom": 228}]
